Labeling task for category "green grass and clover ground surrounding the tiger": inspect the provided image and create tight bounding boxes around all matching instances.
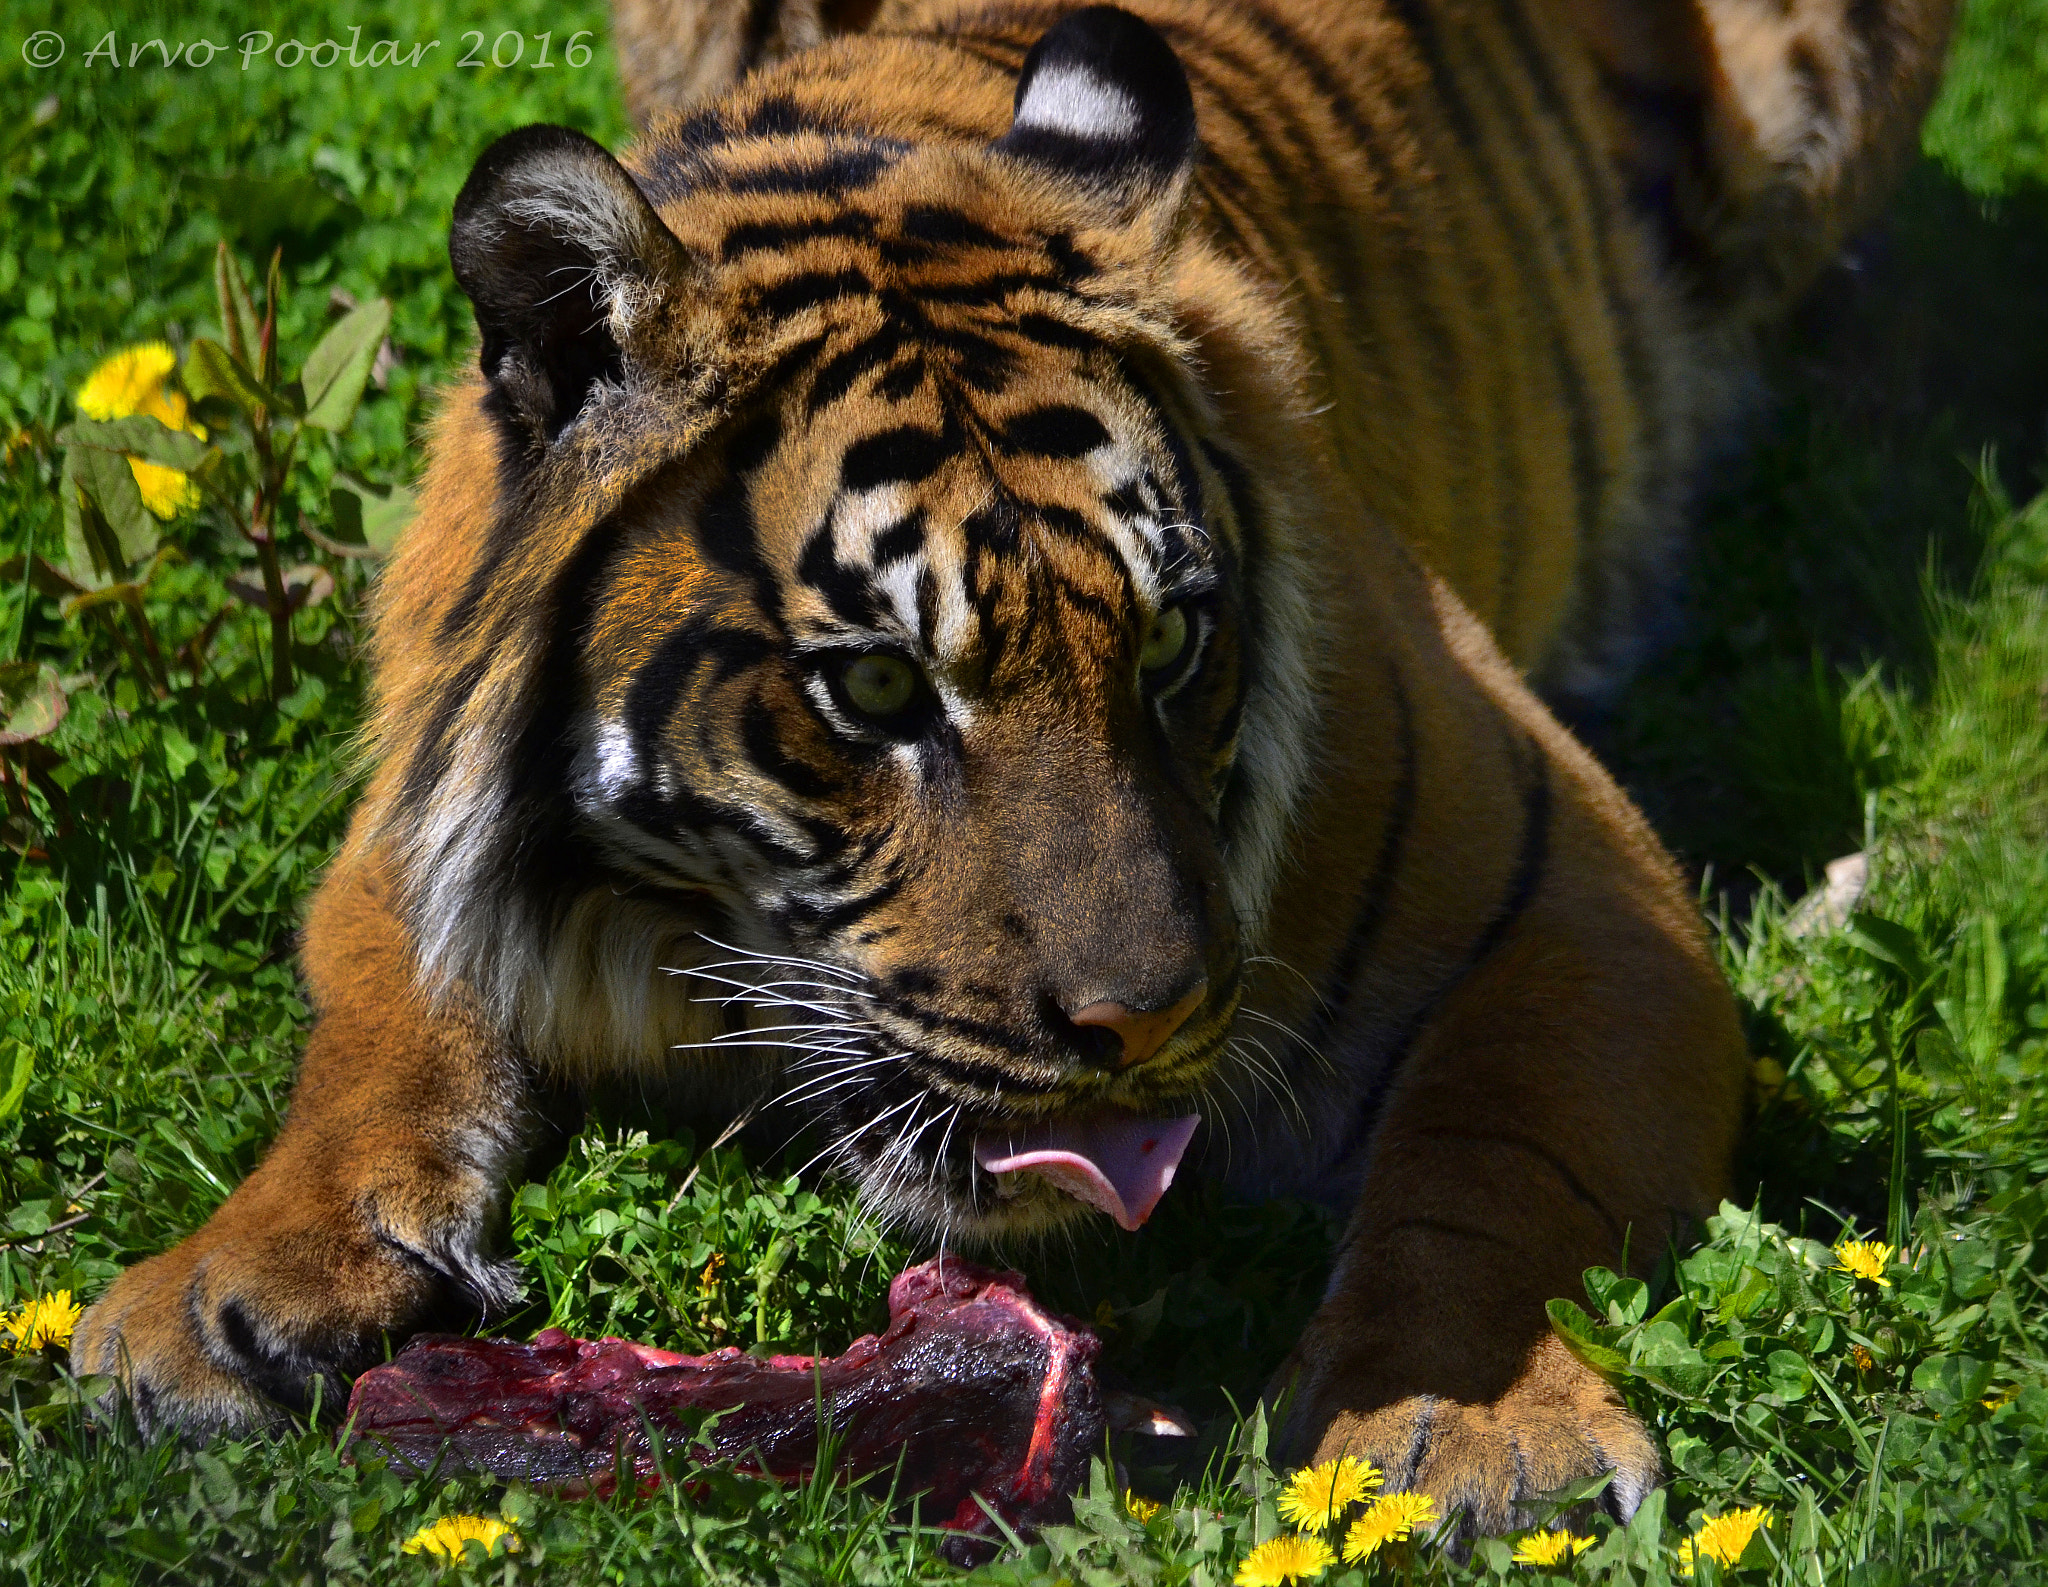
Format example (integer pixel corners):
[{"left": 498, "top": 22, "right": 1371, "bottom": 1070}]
[{"left": 0, "top": 0, "right": 2048, "bottom": 1587}]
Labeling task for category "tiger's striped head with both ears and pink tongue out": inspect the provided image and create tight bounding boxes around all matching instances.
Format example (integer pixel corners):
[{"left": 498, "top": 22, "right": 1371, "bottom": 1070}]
[{"left": 379, "top": 8, "right": 1307, "bottom": 1235}]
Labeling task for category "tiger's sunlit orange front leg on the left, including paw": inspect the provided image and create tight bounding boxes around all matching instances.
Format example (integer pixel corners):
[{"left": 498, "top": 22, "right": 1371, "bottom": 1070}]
[{"left": 72, "top": 858, "right": 528, "bottom": 1435}]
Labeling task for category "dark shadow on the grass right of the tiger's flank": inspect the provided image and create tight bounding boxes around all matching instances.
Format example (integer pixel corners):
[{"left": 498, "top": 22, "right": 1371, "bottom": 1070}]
[{"left": 1585, "top": 162, "right": 2048, "bottom": 892}]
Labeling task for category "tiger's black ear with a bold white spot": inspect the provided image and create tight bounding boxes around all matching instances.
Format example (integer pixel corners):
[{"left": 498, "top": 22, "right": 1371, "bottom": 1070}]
[{"left": 995, "top": 6, "right": 1200, "bottom": 221}]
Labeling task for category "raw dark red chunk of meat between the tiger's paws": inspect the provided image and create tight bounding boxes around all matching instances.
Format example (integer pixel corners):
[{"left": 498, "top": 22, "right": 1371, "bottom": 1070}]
[{"left": 348, "top": 1257, "right": 1104, "bottom": 1534}]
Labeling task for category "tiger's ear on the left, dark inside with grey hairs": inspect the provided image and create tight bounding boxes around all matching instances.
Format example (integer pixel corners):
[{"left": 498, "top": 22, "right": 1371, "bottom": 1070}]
[{"left": 449, "top": 127, "right": 688, "bottom": 444}]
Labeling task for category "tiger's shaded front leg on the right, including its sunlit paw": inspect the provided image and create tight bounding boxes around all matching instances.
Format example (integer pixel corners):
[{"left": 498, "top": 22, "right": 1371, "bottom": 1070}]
[{"left": 1274, "top": 786, "right": 1745, "bottom": 1538}]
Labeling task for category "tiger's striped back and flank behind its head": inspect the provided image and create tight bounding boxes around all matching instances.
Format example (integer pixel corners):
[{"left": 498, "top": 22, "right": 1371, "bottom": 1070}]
[{"left": 614, "top": 0, "right": 1950, "bottom": 704}]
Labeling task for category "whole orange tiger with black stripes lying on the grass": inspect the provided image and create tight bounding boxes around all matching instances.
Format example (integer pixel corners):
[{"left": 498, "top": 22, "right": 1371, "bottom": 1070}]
[{"left": 74, "top": 0, "right": 1950, "bottom": 1538}]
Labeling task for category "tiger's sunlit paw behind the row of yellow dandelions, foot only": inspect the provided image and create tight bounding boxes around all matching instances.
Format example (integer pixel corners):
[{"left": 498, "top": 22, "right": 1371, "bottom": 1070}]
[{"left": 1278, "top": 1339, "right": 1663, "bottom": 1544}]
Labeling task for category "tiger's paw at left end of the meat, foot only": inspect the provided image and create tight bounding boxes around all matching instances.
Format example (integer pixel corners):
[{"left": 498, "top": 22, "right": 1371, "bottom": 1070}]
[{"left": 72, "top": 1198, "right": 518, "bottom": 1438}]
